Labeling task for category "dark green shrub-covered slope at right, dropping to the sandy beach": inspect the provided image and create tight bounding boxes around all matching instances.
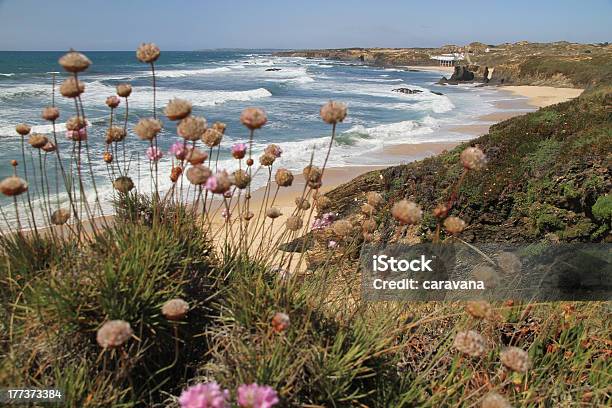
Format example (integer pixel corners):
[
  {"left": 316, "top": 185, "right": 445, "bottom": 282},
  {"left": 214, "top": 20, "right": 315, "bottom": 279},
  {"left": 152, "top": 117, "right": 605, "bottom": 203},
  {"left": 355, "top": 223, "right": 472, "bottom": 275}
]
[{"left": 328, "top": 83, "right": 612, "bottom": 243}]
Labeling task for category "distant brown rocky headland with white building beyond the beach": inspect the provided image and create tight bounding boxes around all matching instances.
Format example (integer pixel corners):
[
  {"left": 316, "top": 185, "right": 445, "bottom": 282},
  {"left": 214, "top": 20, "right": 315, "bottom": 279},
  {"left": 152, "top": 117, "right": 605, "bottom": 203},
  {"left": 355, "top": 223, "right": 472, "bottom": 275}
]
[{"left": 276, "top": 41, "right": 612, "bottom": 88}]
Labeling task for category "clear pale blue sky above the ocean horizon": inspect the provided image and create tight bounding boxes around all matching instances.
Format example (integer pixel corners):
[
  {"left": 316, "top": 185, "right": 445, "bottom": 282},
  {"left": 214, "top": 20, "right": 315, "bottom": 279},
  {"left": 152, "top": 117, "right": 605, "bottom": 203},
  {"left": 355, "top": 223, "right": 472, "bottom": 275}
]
[{"left": 0, "top": 0, "right": 612, "bottom": 50}]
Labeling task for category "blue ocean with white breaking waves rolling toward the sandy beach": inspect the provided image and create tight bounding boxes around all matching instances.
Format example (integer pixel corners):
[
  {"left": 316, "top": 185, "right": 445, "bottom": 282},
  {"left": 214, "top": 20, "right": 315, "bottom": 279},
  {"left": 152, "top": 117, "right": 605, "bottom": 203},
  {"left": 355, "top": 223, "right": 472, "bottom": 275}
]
[{"left": 0, "top": 50, "right": 524, "bottom": 223}]
